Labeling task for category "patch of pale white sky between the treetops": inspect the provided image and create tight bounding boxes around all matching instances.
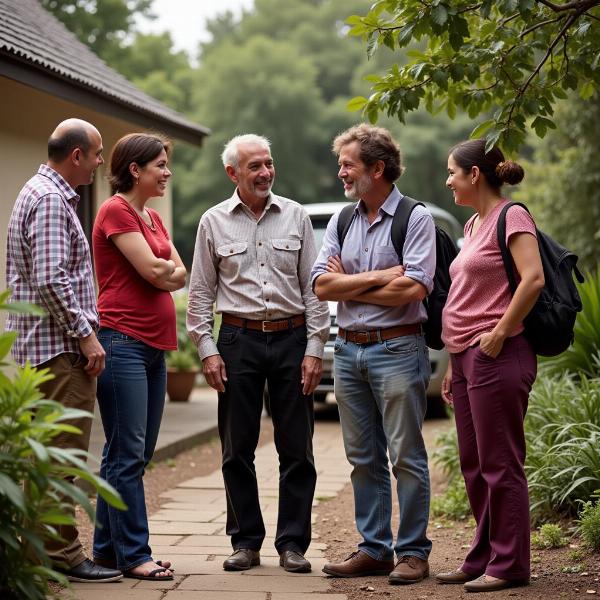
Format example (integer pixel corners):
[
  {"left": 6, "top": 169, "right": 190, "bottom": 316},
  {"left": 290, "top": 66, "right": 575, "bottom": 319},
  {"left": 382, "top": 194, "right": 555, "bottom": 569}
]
[{"left": 138, "top": 0, "right": 254, "bottom": 57}]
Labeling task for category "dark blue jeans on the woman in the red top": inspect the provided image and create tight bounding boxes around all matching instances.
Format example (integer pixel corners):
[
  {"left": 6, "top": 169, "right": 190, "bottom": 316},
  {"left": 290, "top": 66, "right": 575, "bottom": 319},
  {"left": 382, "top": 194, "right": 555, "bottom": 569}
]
[{"left": 94, "top": 328, "right": 166, "bottom": 571}]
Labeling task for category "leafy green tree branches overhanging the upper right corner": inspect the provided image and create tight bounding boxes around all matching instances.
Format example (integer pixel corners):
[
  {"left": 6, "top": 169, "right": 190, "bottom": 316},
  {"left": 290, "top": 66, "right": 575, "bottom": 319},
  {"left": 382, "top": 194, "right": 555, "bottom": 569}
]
[{"left": 347, "top": 0, "right": 600, "bottom": 151}]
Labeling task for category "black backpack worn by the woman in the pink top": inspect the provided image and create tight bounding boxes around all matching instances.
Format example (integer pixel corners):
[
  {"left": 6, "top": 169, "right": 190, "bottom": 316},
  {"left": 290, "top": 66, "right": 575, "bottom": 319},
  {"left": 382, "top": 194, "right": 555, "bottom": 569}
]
[{"left": 498, "top": 202, "right": 583, "bottom": 356}]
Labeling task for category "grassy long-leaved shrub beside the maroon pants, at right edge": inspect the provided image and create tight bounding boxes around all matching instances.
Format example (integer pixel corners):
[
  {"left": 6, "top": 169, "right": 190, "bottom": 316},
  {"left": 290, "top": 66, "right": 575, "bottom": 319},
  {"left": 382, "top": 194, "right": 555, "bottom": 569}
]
[{"left": 525, "top": 374, "right": 600, "bottom": 520}]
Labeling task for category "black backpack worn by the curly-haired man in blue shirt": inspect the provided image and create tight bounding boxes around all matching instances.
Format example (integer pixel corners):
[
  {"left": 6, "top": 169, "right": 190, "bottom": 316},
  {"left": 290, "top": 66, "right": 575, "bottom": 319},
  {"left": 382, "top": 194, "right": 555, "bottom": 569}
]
[{"left": 337, "top": 196, "right": 458, "bottom": 350}]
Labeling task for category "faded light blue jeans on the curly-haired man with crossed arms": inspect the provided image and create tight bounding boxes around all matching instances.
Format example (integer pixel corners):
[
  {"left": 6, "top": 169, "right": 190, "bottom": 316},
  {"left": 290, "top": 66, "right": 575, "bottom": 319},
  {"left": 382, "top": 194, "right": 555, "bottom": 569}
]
[{"left": 334, "top": 335, "right": 431, "bottom": 560}]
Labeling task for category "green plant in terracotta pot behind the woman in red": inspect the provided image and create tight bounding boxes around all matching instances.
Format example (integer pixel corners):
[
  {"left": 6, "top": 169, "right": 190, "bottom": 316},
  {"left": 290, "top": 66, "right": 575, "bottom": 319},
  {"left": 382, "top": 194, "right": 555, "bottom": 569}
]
[{"left": 166, "top": 294, "right": 200, "bottom": 402}]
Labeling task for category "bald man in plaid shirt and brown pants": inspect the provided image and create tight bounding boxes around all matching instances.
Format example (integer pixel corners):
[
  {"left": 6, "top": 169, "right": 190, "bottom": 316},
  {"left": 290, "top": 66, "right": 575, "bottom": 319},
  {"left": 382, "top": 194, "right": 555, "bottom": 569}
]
[{"left": 6, "top": 119, "right": 123, "bottom": 583}]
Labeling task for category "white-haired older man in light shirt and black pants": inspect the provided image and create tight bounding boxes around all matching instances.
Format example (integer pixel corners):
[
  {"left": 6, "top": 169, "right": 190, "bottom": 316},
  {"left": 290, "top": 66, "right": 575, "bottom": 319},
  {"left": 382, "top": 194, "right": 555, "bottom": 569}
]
[{"left": 188, "top": 134, "right": 329, "bottom": 573}]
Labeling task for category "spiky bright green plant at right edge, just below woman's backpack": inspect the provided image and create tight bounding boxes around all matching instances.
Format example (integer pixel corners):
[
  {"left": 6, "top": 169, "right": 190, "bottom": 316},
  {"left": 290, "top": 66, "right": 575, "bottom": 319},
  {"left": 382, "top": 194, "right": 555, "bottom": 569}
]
[{"left": 540, "top": 268, "right": 600, "bottom": 377}]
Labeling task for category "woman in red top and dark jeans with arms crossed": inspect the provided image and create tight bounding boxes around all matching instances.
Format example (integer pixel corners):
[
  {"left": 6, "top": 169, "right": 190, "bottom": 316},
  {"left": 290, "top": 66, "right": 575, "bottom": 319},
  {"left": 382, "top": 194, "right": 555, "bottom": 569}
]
[{"left": 93, "top": 133, "right": 186, "bottom": 579}]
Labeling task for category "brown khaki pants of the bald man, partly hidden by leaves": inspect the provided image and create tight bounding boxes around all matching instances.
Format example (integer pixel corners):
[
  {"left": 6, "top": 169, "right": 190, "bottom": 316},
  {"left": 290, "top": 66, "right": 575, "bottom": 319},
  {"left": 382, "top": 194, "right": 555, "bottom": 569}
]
[{"left": 38, "top": 352, "right": 96, "bottom": 568}]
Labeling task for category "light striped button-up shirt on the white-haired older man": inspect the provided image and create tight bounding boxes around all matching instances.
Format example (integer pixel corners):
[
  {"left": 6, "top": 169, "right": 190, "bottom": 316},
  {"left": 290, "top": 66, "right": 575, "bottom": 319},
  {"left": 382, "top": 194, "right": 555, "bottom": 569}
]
[{"left": 187, "top": 190, "right": 329, "bottom": 359}]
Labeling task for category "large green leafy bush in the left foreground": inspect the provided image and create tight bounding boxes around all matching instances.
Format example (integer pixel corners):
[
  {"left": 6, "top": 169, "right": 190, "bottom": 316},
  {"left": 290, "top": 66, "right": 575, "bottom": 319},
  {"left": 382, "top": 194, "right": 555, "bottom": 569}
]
[{"left": 0, "top": 292, "right": 125, "bottom": 600}]
